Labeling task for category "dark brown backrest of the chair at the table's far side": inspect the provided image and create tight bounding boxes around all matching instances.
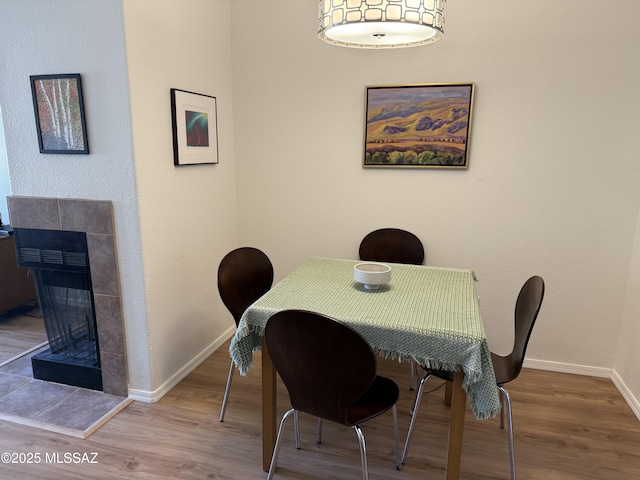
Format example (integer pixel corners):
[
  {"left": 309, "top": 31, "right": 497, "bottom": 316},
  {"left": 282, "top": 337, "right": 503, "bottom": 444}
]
[{"left": 359, "top": 228, "right": 424, "bottom": 265}]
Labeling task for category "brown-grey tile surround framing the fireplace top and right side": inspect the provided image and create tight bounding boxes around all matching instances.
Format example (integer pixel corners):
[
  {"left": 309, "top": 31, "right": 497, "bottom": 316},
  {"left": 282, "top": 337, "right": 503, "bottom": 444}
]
[{"left": 7, "top": 195, "right": 128, "bottom": 397}]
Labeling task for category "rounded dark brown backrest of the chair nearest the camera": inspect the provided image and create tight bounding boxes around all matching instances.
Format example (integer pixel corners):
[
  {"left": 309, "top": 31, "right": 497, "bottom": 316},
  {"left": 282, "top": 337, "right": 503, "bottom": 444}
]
[{"left": 265, "top": 310, "right": 376, "bottom": 425}]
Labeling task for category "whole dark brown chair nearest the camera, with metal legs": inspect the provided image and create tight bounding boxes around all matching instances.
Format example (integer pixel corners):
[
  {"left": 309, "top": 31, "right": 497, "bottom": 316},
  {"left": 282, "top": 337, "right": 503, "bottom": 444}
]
[{"left": 265, "top": 310, "right": 400, "bottom": 480}]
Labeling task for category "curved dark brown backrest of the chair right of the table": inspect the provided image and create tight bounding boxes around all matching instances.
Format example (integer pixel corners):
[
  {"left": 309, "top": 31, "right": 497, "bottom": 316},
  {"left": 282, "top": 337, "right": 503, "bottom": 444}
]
[{"left": 504, "top": 275, "right": 544, "bottom": 383}]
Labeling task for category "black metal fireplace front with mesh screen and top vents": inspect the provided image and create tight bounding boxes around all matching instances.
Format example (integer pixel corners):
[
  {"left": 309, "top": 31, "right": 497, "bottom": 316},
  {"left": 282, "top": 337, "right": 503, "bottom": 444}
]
[{"left": 14, "top": 228, "right": 102, "bottom": 390}]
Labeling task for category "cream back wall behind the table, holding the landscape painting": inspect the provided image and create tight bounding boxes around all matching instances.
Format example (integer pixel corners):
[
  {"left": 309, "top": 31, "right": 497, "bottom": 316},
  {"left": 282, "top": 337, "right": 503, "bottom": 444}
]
[{"left": 232, "top": 0, "right": 640, "bottom": 386}]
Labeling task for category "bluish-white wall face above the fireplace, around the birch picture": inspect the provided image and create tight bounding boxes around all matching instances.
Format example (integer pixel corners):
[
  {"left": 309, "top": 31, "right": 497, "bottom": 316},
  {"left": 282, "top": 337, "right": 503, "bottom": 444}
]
[{"left": 0, "top": 0, "right": 149, "bottom": 385}]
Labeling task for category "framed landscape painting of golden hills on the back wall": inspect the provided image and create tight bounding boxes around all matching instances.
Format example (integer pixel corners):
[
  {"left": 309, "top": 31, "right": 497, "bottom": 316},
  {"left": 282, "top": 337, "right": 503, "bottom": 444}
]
[{"left": 363, "top": 83, "right": 475, "bottom": 169}]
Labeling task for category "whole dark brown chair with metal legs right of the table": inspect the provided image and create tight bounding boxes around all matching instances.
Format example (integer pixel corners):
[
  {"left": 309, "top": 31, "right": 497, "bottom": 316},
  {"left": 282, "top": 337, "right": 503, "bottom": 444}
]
[{"left": 401, "top": 276, "right": 544, "bottom": 480}]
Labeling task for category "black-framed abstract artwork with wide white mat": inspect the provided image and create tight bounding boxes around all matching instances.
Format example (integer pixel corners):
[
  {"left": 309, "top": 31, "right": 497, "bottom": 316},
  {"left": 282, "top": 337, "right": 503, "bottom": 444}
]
[{"left": 171, "top": 88, "right": 218, "bottom": 166}]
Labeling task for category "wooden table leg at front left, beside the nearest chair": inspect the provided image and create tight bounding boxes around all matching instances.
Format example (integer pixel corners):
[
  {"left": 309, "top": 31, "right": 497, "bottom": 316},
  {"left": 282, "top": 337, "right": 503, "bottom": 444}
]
[{"left": 262, "top": 338, "right": 277, "bottom": 472}]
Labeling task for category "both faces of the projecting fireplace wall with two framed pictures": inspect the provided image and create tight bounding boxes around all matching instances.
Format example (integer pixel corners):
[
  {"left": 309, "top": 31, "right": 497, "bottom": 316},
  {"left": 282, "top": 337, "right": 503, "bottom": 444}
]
[{"left": 0, "top": 0, "right": 237, "bottom": 401}]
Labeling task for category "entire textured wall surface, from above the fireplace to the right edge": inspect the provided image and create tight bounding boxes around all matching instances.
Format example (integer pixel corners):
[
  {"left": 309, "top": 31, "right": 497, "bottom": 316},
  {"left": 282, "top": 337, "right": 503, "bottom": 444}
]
[{"left": 0, "top": 0, "right": 640, "bottom": 412}]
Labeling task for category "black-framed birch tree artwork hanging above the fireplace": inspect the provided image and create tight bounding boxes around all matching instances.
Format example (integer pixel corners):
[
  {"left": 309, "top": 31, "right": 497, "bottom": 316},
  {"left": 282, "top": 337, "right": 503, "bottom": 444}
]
[{"left": 29, "top": 74, "right": 89, "bottom": 154}]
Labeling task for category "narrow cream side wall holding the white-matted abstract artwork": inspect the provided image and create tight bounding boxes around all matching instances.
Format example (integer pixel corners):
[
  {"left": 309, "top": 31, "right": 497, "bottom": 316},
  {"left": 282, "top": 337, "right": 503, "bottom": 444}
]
[{"left": 123, "top": 0, "right": 238, "bottom": 400}]
